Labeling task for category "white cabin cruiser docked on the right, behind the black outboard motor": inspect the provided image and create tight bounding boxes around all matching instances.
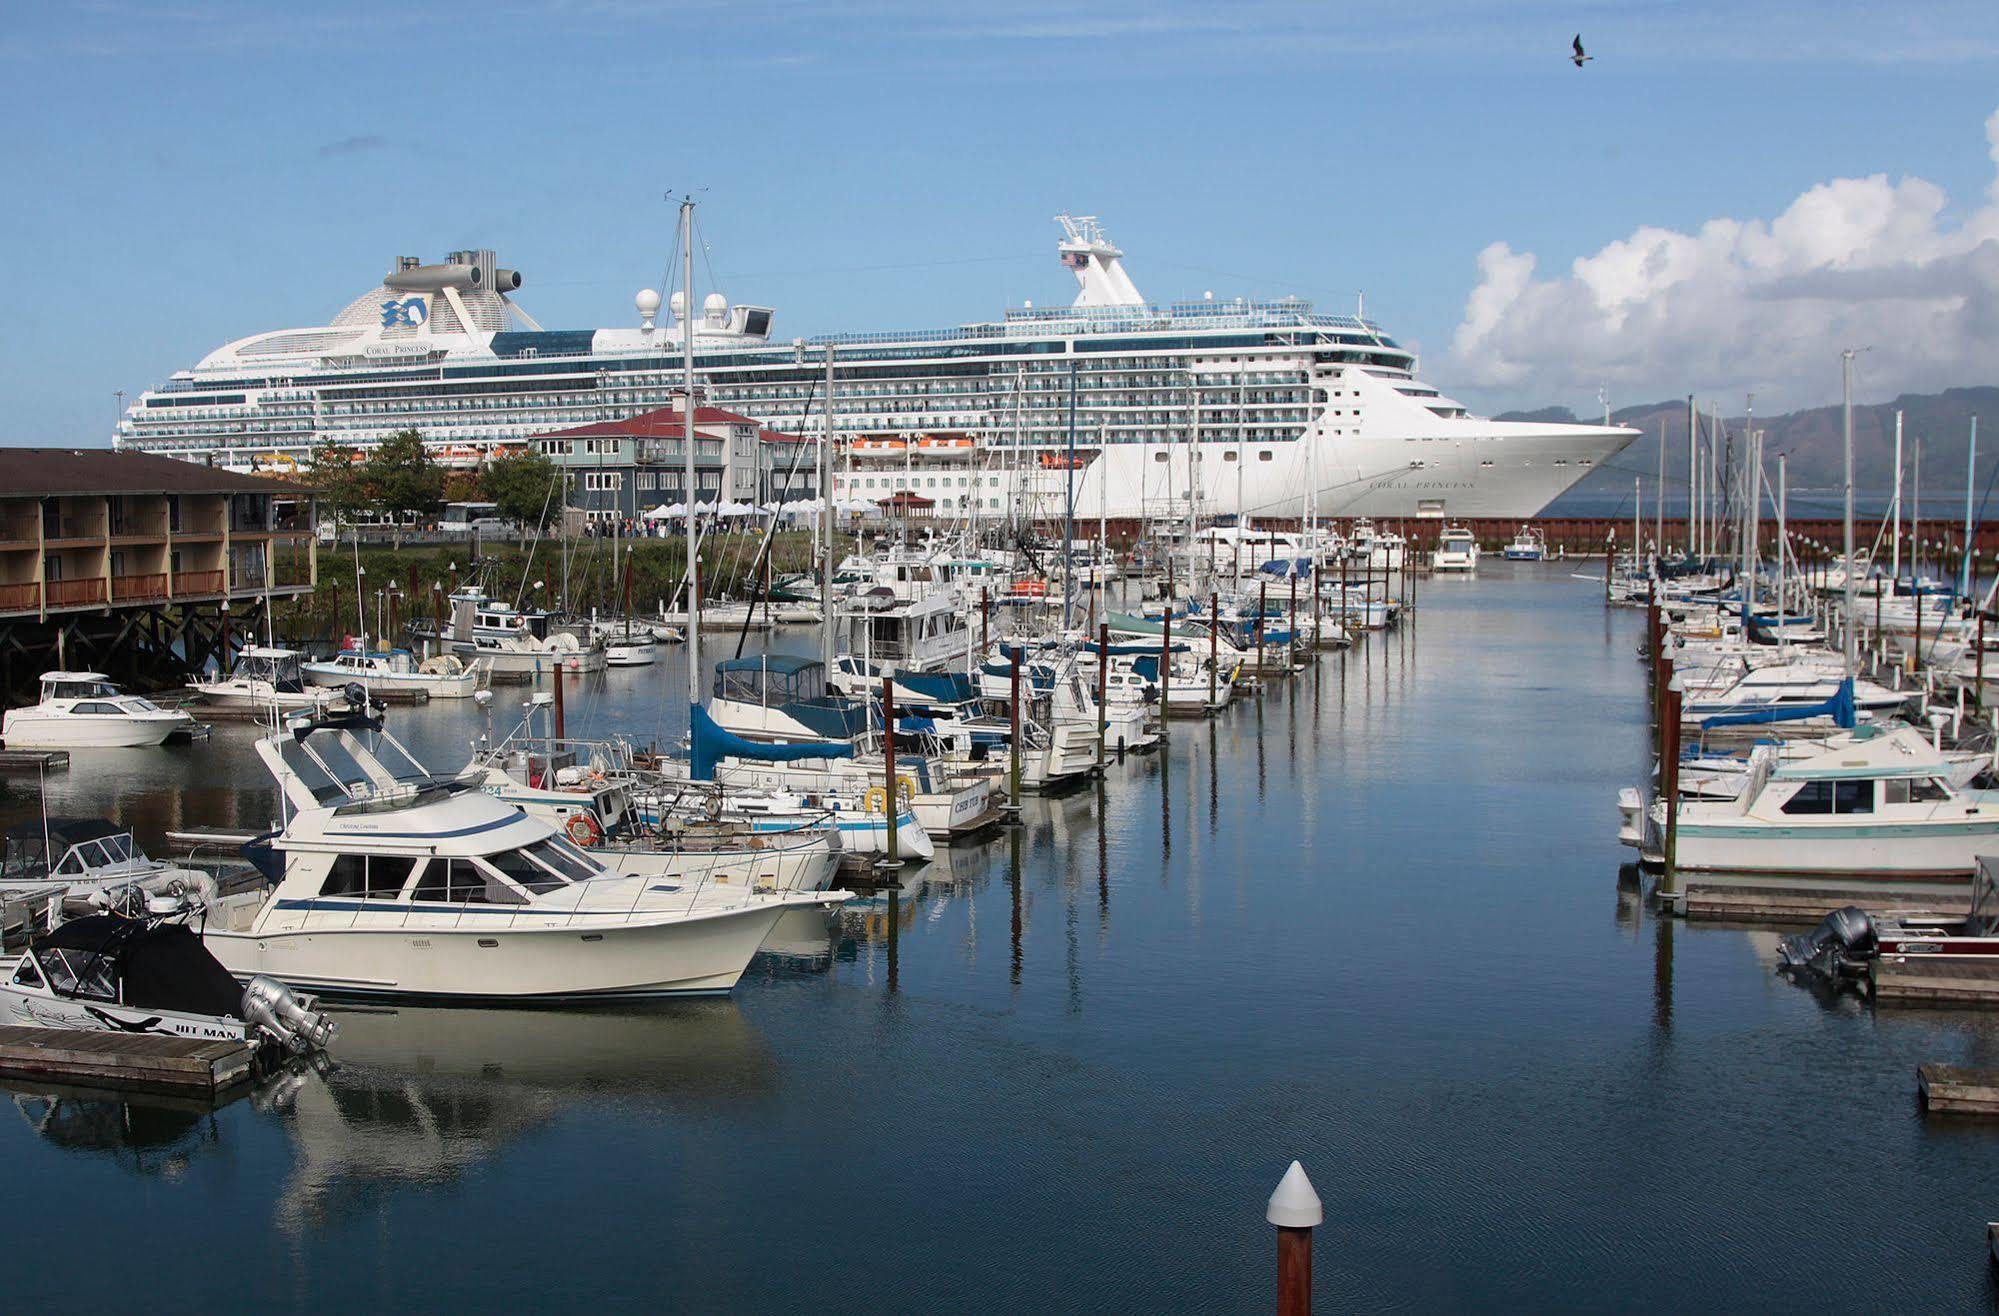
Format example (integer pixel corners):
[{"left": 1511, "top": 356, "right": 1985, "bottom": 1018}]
[{"left": 1621, "top": 726, "right": 1999, "bottom": 878}]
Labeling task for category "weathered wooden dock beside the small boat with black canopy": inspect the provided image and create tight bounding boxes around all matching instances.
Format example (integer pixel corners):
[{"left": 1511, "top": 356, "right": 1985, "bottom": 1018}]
[{"left": 0, "top": 1028, "right": 256, "bottom": 1096}]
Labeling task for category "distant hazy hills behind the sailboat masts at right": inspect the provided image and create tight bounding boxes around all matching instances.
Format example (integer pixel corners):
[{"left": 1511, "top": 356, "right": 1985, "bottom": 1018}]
[{"left": 1495, "top": 386, "right": 1999, "bottom": 512}]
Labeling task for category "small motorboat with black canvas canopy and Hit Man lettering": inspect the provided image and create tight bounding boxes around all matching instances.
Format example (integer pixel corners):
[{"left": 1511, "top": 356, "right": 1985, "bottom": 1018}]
[{"left": 0, "top": 902, "right": 336, "bottom": 1054}]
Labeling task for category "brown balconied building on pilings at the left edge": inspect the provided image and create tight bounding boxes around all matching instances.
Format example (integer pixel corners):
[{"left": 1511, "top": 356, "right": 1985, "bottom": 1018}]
[{"left": 0, "top": 448, "right": 318, "bottom": 702}]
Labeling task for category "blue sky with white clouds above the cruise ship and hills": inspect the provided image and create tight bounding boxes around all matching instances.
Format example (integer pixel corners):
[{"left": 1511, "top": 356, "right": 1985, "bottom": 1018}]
[{"left": 0, "top": 0, "right": 1999, "bottom": 444}]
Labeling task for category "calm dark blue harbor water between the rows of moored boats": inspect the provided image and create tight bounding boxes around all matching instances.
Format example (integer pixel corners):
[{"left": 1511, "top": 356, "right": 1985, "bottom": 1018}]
[{"left": 0, "top": 562, "right": 1999, "bottom": 1310}]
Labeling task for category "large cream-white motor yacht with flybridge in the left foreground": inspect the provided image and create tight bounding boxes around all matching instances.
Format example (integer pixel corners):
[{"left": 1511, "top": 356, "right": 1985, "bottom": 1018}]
[{"left": 202, "top": 690, "right": 848, "bottom": 988}]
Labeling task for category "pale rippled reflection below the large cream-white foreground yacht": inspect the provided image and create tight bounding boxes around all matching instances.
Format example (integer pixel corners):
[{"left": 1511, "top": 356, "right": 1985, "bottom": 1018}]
[{"left": 278, "top": 1000, "right": 778, "bottom": 1228}]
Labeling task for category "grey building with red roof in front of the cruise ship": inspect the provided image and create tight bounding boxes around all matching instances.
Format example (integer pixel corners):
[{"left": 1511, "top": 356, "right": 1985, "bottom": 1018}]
[{"left": 528, "top": 394, "right": 818, "bottom": 522}]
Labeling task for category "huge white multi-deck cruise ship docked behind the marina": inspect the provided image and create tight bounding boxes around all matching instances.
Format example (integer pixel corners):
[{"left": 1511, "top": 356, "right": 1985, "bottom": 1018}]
[{"left": 114, "top": 216, "right": 1637, "bottom": 518}]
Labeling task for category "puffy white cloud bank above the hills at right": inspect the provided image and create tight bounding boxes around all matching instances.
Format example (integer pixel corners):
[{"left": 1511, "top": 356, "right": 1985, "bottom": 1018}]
[{"left": 1449, "top": 112, "right": 1999, "bottom": 404}]
